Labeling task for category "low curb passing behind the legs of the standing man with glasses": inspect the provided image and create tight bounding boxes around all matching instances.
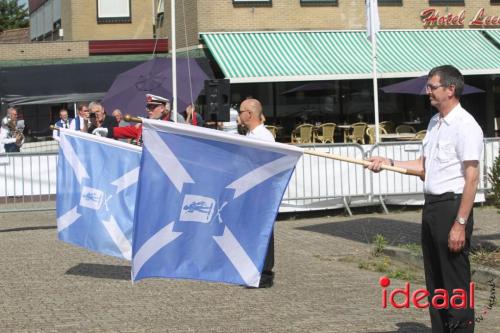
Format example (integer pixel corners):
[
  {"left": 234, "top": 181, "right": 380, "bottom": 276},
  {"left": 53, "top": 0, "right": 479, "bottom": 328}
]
[{"left": 382, "top": 246, "right": 500, "bottom": 284}]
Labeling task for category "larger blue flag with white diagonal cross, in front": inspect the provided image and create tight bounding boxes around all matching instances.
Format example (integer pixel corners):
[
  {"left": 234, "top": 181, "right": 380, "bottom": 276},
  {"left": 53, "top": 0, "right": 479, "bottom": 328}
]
[{"left": 132, "top": 120, "right": 302, "bottom": 286}]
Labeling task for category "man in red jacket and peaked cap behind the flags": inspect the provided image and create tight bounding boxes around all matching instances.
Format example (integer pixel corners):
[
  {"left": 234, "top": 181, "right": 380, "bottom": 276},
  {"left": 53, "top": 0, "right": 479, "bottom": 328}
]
[{"left": 92, "top": 94, "right": 185, "bottom": 145}]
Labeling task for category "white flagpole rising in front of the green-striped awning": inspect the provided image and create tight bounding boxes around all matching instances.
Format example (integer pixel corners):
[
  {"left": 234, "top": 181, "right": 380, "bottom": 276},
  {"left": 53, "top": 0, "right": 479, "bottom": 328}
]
[{"left": 366, "top": 0, "right": 380, "bottom": 143}]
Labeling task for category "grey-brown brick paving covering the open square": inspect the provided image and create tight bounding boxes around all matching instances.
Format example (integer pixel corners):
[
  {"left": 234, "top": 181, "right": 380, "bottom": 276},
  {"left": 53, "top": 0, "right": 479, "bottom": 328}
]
[{"left": 0, "top": 207, "right": 500, "bottom": 333}]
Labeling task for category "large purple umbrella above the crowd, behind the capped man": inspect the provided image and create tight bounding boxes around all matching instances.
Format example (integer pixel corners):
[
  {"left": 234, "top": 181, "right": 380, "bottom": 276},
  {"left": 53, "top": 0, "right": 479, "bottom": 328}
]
[{"left": 102, "top": 58, "right": 213, "bottom": 116}]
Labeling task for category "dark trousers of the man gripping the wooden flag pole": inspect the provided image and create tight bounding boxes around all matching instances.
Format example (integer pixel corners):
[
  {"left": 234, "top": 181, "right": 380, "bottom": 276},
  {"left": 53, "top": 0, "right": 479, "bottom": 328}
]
[{"left": 422, "top": 193, "right": 474, "bottom": 333}]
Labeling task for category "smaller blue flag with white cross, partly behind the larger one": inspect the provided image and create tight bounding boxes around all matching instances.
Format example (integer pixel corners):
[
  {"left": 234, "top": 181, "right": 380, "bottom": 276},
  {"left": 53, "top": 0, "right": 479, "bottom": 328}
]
[{"left": 56, "top": 129, "right": 141, "bottom": 260}]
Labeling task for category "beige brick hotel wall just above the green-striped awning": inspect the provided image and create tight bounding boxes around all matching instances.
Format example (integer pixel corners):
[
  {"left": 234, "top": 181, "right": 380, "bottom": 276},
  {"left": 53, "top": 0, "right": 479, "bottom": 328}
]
[{"left": 158, "top": 0, "right": 500, "bottom": 48}]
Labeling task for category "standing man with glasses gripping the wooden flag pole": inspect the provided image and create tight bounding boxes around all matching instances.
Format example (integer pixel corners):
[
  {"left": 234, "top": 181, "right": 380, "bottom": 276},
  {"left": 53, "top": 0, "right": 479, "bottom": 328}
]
[{"left": 368, "top": 65, "right": 483, "bottom": 332}]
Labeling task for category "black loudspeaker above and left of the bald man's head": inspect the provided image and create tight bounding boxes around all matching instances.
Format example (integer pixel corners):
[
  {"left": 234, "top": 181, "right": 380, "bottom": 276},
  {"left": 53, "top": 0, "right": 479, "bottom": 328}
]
[{"left": 204, "top": 79, "right": 231, "bottom": 121}]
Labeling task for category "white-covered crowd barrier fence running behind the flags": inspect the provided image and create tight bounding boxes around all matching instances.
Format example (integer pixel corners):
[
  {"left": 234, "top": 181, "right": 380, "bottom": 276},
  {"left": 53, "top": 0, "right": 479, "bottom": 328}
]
[{"left": 0, "top": 138, "right": 500, "bottom": 213}]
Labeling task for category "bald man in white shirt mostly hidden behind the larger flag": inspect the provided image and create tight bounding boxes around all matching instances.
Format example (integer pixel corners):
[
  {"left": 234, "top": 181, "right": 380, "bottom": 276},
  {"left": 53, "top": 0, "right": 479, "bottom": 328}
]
[{"left": 239, "top": 99, "right": 274, "bottom": 288}]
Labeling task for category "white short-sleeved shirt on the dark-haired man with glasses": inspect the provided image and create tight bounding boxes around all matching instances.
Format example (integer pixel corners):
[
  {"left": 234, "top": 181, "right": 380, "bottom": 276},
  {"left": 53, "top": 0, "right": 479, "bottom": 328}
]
[{"left": 422, "top": 104, "right": 483, "bottom": 194}]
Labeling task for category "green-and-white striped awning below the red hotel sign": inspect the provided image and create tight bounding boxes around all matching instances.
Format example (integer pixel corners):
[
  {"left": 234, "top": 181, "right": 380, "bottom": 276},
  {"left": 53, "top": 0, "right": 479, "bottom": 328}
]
[{"left": 201, "top": 30, "right": 500, "bottom": 83}]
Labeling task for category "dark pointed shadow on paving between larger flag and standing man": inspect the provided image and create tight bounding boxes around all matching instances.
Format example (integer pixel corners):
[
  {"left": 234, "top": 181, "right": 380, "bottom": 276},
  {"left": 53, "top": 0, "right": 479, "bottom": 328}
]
[{"left": 297, "top": 218, "right": 420, "bottom": 245}]
